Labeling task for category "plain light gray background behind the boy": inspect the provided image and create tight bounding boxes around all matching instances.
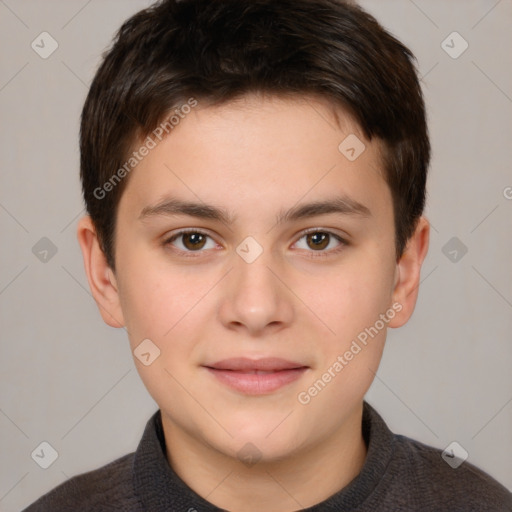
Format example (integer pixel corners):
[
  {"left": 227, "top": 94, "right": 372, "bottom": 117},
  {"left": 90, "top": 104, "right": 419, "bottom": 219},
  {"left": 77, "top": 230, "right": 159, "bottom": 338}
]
[{"left": 0, "top": 0, "right": 512, "bottom": 511}]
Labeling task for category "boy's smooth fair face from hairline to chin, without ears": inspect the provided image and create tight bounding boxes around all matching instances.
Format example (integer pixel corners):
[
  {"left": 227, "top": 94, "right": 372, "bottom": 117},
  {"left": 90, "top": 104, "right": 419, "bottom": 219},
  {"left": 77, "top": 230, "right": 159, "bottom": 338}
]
[{"left": 82, "top": 96, "right": 422, "bottom": 460}]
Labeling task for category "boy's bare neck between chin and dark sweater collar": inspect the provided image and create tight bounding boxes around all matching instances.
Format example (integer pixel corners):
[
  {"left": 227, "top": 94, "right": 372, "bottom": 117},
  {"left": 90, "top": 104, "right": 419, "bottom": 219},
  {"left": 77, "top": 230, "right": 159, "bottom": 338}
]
[{"left": 162, "top": 404, "right": 366, "bottom": 512}]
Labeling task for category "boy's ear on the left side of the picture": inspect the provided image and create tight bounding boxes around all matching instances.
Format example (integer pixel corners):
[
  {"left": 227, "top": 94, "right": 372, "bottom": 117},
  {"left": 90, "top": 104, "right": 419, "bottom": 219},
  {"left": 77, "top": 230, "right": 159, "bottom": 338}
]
[{"left": 77, "top": 216, "right": 124, "bottom": 327}]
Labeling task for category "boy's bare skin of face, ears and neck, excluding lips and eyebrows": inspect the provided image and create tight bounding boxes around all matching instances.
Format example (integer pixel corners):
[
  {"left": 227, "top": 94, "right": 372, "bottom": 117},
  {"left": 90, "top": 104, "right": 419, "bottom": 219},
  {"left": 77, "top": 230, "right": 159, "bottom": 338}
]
[{"left": 78, "top": 95, "right": 429, "bottom": 512}]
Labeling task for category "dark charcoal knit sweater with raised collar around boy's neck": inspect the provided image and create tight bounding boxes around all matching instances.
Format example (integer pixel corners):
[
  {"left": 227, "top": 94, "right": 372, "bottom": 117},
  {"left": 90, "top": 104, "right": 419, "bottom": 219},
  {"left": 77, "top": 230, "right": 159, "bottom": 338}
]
[{"left": 24, "top": 401, "right": 512, "bottom": 512}]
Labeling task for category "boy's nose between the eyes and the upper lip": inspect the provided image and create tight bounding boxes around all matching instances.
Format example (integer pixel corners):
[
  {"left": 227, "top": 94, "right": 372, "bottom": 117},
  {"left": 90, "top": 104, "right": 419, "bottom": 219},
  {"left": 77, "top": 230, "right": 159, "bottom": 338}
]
[{"left": 219, "top": 247, "right": 295, "bottom": 336}]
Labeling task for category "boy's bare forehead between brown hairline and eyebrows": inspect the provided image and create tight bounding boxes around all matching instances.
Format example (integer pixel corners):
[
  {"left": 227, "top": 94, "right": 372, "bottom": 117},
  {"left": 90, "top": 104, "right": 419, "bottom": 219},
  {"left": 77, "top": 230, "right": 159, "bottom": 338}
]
[{"left": 120, "top": 95, "right": 391, "bottom": 226}]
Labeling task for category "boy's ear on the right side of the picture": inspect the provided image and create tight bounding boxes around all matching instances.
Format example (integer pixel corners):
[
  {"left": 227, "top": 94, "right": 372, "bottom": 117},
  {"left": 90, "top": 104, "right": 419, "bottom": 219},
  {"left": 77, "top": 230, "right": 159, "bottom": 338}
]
[{"left": 388, "top": 217, "right": 430, "bottom": 327}]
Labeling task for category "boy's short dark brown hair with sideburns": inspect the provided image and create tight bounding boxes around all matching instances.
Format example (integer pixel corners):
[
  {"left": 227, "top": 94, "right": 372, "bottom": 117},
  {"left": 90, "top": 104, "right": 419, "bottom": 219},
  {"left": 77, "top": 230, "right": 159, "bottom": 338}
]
[{"left": 80, "top": 0, "right": 430, "bottom": 269}]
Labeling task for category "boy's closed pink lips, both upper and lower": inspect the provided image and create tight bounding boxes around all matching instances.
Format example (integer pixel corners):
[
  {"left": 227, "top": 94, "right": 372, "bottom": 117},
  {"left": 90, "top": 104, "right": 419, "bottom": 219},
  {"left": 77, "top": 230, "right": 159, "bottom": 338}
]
[{"left": 204, "top": 357, "right": 308, "bottom": 395}]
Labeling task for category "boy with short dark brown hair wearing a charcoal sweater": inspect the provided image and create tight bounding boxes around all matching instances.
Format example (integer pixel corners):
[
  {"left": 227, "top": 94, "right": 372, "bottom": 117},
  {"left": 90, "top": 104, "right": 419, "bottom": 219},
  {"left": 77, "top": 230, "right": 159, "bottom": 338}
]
[{"left": 23, "top": 0, "right": 512, "bottom": 512}]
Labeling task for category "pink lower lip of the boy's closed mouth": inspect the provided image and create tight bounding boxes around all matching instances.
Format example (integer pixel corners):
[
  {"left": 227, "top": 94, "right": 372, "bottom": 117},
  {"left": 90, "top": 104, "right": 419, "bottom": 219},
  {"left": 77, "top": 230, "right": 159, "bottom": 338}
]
[{"left": 207, "top": 368, "right": 307, "bottom": 395}]
